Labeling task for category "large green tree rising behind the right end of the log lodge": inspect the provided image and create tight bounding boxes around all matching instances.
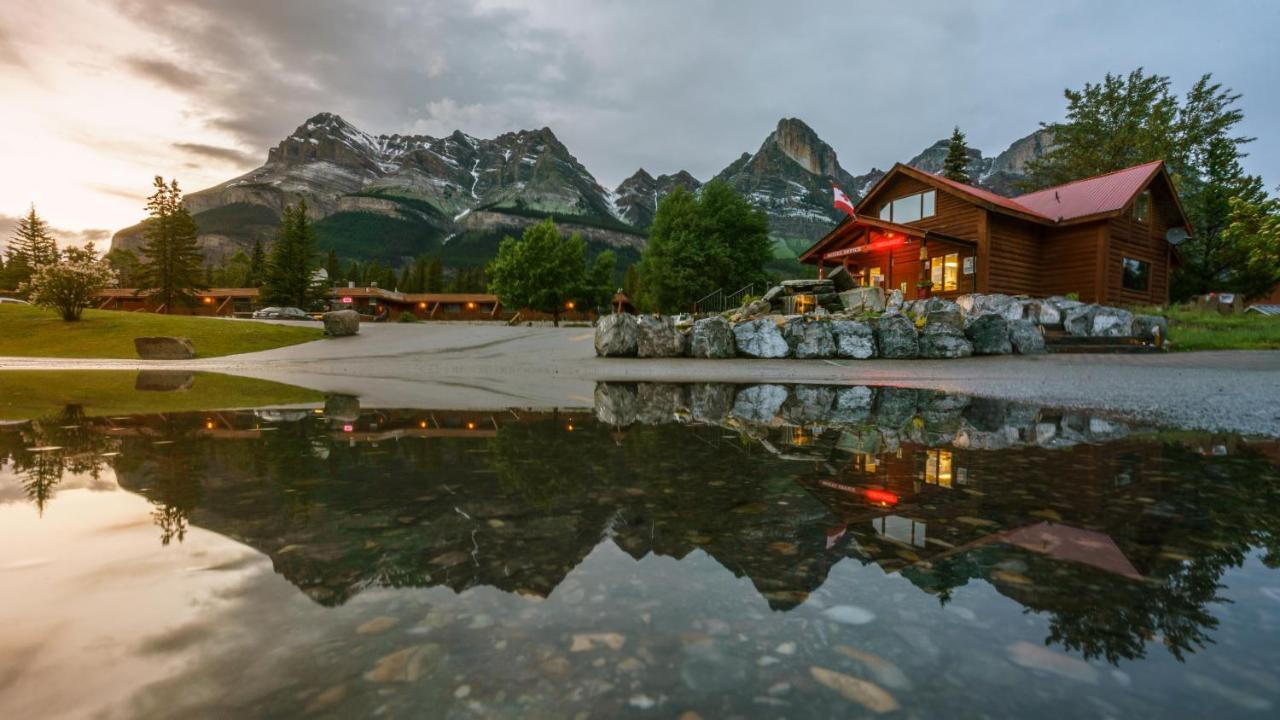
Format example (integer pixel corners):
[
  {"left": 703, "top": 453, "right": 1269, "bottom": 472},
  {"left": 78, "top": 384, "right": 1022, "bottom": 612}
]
[{"left": 1024, "top": 68, "right": 1265, "bottom": 300}]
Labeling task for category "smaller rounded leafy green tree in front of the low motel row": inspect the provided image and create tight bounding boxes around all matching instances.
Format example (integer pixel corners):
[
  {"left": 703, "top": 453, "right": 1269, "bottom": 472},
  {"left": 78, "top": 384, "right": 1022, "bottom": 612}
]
[{"left": 488, "top": 218, "right": 613, "bottom": 327}]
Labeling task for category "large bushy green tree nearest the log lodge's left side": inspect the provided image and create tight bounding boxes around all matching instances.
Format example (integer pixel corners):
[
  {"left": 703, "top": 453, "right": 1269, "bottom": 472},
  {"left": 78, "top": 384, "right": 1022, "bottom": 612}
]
[{"left": 632, "top": 181, "right": 773, "bottom": 313}]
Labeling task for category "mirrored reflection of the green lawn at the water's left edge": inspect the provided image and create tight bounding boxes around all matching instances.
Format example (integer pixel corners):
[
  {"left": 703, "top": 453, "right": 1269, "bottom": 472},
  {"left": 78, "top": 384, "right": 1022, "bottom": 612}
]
[{"left": 0, "top": 370, "right": 324, "bottom": 420}]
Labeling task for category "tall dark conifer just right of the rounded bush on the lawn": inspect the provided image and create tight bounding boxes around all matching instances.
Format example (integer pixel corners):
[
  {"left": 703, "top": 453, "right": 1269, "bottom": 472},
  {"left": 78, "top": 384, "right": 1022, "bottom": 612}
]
[{"left": 141, "top": 176, "right": 204, "bottom": 313}]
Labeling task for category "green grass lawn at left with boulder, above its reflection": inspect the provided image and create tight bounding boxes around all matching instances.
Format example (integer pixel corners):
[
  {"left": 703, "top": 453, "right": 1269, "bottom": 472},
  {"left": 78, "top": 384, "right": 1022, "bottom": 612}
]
[{"left": 0, "top": 304, "right": 323, "bottom": 357}]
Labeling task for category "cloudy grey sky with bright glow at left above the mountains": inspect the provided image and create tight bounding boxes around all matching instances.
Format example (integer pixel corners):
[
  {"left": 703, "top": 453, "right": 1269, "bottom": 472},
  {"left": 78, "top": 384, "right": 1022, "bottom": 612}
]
[{"left": 0, "top": 0, "right": 1280, "bottom": 245}]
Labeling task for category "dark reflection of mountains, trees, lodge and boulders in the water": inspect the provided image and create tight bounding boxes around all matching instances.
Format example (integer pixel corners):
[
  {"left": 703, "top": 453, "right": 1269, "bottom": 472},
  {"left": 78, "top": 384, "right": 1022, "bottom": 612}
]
[{"left": 0, "top": 386, "right": 1280, "bottom": 660}]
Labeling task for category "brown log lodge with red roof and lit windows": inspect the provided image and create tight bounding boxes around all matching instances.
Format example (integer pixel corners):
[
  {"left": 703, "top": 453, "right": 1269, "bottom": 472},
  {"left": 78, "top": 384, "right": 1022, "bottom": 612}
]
[{"left": 800, "top": 161, "right": 1190, "bottom": 305}]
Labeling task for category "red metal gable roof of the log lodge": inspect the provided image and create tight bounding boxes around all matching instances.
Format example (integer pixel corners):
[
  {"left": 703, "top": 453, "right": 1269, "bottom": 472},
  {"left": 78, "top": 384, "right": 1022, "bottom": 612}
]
[{"left": 858, "top": 160, "right": 1183, "bottom": 225}]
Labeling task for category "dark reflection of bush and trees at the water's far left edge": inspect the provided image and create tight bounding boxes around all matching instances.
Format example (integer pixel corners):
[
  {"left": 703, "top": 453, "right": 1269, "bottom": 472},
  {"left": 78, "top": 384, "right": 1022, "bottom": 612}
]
[{"left": 0, "top": 405, "right": 116, "bottom": 515}]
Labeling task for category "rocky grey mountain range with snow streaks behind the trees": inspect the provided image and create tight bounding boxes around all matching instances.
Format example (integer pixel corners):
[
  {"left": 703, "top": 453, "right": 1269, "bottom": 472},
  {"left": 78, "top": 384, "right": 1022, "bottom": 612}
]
[{"left": 111, "top": 113, "right": 1051, "bottom": 268}]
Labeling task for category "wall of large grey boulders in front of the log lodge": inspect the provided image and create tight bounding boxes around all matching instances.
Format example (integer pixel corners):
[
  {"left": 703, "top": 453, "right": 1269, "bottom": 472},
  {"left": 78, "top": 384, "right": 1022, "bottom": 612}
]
[{"left": 595, "top": 286, "right": 1167, "bottom": 360}]
